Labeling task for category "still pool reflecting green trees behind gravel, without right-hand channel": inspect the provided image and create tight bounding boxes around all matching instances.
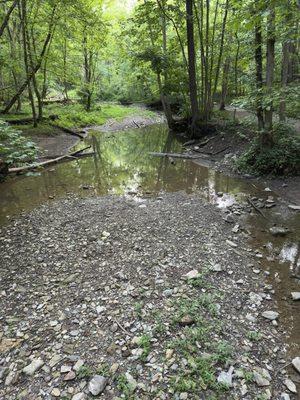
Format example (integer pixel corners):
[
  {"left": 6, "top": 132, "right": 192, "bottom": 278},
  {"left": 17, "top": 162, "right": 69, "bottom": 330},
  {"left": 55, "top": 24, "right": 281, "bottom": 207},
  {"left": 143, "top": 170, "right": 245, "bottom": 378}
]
[{"left": 0, "top": 124, "right": 253, "bottom": 223}]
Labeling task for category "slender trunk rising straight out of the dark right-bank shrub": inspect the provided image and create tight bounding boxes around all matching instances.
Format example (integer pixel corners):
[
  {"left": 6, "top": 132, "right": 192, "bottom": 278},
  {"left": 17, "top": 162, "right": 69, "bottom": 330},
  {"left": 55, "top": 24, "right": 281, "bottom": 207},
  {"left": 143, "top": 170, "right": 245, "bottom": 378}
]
[{"left": 265, "top": 8, "right": 275, "bottom": 134}]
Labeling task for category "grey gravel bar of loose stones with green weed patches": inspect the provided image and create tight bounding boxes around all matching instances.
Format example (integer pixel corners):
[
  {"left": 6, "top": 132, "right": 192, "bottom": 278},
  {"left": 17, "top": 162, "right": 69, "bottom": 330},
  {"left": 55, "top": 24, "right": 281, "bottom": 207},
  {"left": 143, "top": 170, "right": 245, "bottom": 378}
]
[{"left": 0, "top": 193, "right": 300, "bottom": 400}]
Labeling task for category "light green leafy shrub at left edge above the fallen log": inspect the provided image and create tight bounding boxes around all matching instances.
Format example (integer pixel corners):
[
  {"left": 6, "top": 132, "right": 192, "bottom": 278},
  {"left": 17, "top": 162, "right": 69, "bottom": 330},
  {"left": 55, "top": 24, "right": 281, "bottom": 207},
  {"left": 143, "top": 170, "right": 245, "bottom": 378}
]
[{"left": 0, "top": 120, "right": 37, "bottom": 165}]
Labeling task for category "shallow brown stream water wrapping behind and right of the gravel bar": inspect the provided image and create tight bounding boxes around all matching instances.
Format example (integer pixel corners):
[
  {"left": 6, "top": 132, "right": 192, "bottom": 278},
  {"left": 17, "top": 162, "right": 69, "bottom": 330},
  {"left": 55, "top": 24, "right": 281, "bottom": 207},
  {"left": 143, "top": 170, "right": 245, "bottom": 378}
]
[{"left": 0, "top": 124, "right": 300, "bottom": 381}]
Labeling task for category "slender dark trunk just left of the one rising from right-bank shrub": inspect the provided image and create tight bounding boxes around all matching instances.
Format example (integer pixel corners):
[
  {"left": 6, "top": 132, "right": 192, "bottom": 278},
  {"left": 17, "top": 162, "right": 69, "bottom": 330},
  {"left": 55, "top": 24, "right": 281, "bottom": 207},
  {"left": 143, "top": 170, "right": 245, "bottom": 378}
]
[{"left": 255, "top": 15, "right": 265, "bottom": 130}]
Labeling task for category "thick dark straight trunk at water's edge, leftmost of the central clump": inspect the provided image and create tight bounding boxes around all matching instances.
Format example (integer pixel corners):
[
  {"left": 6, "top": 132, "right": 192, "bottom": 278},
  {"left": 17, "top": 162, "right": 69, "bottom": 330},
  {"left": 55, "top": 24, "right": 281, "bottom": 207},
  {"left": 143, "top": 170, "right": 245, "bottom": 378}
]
[{"left": 186, "top": 0, "right": 199, "bottom": 136}]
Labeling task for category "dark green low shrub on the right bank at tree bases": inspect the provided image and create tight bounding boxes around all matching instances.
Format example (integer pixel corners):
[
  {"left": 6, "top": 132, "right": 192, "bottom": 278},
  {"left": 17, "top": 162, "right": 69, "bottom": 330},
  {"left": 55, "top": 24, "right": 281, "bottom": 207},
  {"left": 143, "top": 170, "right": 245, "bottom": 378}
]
[{"left": 235, "top": 123, "right": 300, "bottom": 175}]
